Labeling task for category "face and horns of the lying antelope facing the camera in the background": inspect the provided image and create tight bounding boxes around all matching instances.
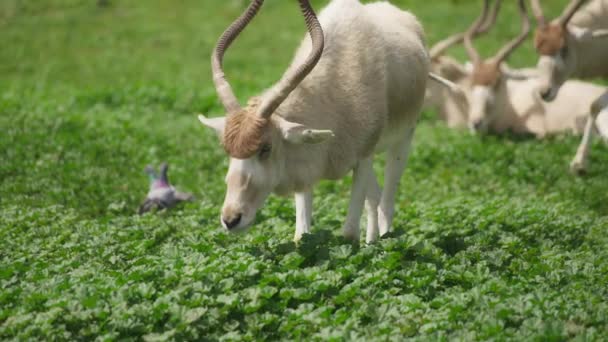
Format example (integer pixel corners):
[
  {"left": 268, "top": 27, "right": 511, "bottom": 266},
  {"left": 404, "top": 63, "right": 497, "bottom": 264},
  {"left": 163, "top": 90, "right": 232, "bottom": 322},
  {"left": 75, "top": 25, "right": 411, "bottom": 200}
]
[{"left": 464, "top": 0, "right": 530, "bottom": 131}]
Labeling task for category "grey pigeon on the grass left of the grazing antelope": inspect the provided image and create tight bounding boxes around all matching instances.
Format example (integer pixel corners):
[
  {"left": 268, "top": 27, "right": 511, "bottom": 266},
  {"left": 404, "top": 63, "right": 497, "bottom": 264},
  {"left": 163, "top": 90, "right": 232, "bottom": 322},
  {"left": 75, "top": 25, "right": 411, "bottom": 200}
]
[{"left": 139, "top": 163, "right": 192, "bottom": 215}]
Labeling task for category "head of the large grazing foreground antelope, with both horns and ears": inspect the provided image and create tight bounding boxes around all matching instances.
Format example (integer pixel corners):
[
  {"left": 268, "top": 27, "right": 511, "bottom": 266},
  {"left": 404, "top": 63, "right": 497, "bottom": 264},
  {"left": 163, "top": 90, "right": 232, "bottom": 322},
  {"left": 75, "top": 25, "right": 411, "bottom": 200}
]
[{"left": 199, "top": 0, "right": 333, "bottom": 232}]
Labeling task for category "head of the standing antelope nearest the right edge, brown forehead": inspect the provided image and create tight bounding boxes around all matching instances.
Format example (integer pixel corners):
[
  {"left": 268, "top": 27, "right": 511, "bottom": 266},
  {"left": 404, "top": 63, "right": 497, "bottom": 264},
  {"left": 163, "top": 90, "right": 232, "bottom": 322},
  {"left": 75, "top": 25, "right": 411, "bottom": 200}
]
[{"left": 531, "top": 0, "right": 589, "bottom": 101}]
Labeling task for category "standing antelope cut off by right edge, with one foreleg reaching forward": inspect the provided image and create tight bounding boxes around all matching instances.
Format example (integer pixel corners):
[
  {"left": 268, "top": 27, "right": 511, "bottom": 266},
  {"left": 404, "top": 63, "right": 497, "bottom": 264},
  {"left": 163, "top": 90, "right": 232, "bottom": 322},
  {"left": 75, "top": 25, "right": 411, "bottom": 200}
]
[{"left": 531, "top": 0, "right": 608, "bottom": 173}]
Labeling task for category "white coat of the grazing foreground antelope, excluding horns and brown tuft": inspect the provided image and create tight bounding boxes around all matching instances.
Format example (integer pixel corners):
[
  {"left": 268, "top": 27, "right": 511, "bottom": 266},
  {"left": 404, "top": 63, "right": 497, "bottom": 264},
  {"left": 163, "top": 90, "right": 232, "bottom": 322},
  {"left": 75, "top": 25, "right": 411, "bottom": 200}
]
[{"left": 201, "top": 0, "right": 429, "bottom": 242}]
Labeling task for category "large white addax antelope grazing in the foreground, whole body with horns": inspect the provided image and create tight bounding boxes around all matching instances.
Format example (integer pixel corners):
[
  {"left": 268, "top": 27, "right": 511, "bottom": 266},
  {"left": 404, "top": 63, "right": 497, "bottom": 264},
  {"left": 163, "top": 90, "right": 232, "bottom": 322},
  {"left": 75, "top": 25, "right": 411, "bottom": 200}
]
[{"left": 199, "top": 0, "right": 429, "bottom": 242}]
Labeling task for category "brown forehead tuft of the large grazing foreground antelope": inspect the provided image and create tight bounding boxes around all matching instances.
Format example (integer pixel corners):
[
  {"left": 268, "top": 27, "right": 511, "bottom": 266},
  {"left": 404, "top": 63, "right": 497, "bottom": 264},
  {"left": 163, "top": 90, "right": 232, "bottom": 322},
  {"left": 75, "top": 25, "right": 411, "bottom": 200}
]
[{"left": 223, "top": 99, "right": 269, "bottom": 159}]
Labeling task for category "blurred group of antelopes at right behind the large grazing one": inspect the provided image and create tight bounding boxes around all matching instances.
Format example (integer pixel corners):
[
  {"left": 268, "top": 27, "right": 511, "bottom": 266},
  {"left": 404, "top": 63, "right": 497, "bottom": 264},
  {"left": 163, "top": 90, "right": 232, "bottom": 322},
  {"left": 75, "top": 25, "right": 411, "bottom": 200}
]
[{"left": 425, "top": 0, "right": 608, "bottom": 173}]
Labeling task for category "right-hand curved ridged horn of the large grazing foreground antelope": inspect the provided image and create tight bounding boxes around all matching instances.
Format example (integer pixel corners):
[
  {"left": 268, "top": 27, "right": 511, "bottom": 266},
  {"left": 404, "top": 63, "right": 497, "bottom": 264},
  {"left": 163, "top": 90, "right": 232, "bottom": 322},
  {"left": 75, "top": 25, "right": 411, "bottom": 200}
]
[{"left": 257, "top": 0, "right": 324, "bottom": 118}]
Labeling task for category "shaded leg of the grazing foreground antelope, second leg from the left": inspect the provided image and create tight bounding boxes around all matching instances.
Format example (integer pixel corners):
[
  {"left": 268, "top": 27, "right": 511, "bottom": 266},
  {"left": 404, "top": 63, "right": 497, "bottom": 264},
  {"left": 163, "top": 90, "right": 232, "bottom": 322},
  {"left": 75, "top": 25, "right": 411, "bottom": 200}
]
[{"left": 344, "top": 157, "right": 374, "bottom": 241}]
